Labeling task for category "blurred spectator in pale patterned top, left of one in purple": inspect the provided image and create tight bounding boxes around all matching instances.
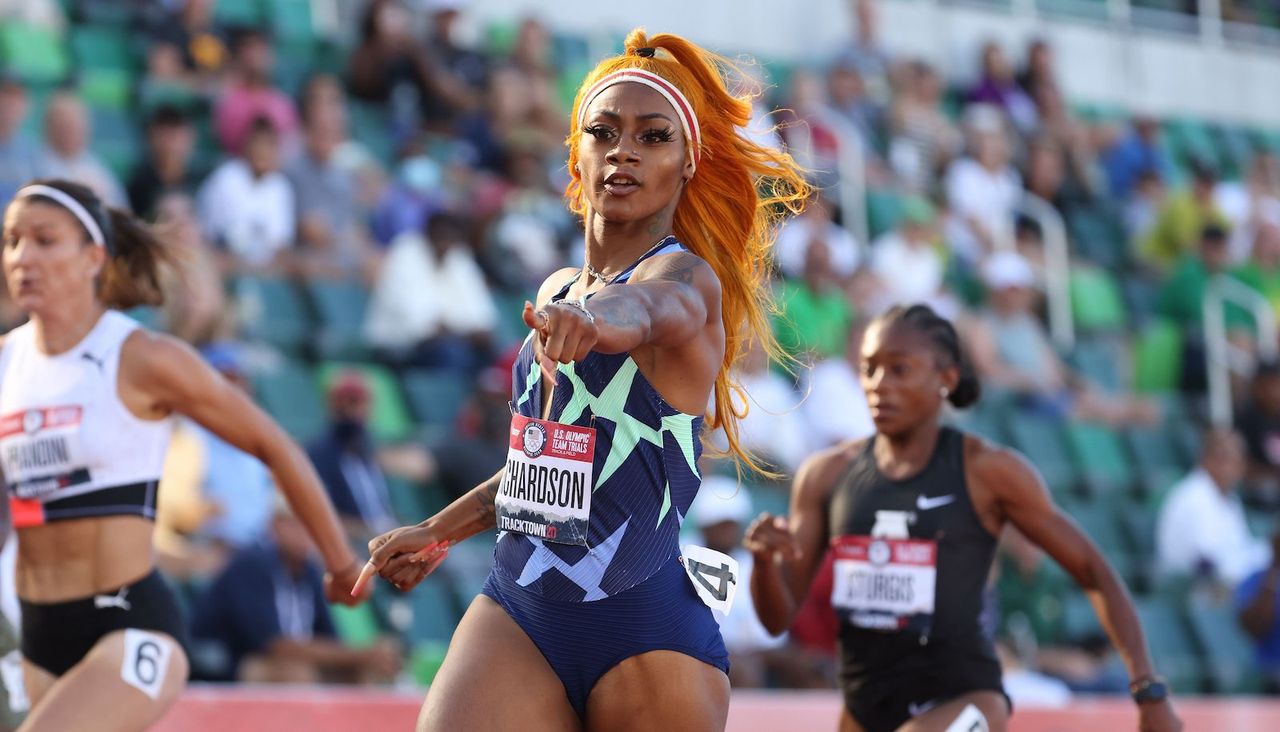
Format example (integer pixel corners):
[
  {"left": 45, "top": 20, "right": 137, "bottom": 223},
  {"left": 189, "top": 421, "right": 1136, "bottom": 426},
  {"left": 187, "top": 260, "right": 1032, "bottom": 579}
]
[{"left": 888, "top": 61, "right": 964, "bottom": 193}]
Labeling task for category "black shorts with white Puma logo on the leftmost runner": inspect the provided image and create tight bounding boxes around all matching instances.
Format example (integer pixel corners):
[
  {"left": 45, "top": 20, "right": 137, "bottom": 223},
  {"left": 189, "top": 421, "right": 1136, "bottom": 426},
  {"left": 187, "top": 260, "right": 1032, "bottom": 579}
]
[{"left": 19, "top": 571, "right": 187, "bottom": 676}]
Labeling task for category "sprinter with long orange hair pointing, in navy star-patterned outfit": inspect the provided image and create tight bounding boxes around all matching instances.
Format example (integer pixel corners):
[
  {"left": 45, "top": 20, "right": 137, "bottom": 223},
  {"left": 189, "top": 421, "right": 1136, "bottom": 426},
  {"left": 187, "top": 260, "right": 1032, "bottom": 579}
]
[{"left": 355, "top": 31, "right": 806, "bottom": 731}]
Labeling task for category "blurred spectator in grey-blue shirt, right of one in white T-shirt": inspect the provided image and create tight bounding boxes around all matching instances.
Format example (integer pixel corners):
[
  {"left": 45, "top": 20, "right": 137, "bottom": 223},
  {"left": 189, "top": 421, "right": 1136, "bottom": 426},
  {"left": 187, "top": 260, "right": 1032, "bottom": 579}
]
[{"left": 293, "top": 74, "right": 378, "bottom": 282}]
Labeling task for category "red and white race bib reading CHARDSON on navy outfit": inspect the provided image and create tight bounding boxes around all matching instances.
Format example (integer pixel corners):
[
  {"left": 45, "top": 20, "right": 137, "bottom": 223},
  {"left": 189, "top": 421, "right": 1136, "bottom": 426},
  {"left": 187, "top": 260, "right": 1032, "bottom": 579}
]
[{"left": 494, "top": 415, "right": 595, "bottom": 546}]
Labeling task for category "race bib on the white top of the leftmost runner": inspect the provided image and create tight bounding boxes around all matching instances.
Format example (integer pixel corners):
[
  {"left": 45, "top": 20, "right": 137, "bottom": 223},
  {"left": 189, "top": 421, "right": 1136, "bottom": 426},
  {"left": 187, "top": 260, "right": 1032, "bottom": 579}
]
[{"left": 0, "top": 406, "right": 92, "bottom": 500}]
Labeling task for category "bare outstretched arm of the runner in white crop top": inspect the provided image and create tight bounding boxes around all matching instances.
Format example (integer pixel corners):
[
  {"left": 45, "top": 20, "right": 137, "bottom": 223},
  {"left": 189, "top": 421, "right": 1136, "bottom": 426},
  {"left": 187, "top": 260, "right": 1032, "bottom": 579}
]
[{"left": 120, "top": 331, "right": 362, "bottom": 604}]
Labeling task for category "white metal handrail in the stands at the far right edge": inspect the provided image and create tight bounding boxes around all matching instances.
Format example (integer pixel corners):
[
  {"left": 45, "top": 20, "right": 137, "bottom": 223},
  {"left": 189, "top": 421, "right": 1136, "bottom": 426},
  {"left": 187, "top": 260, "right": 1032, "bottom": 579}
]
[{"left": 1202, "top": 274, "right": 1277, "bottom": 427}]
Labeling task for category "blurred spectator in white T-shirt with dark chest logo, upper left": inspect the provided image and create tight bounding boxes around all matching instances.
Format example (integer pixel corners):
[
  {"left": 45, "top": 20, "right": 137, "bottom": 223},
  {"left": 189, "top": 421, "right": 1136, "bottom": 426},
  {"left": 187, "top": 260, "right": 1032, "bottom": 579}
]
[{"left": 200, "top": 118, "right": 296, "bottom": 269}]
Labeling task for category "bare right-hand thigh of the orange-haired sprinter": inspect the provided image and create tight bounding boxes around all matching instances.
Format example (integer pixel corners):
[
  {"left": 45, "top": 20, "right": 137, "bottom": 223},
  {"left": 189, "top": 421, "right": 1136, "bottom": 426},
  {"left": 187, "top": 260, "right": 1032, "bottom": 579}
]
[{"left": 586, "top": 650, "right": 728, "bottom": 732}]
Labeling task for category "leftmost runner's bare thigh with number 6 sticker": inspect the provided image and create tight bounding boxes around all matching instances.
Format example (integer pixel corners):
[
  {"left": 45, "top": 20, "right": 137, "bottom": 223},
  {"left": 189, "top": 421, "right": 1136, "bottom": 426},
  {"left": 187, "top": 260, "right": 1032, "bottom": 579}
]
[{"left": 22, "top": 630, "right": 187, "bottom": 732}]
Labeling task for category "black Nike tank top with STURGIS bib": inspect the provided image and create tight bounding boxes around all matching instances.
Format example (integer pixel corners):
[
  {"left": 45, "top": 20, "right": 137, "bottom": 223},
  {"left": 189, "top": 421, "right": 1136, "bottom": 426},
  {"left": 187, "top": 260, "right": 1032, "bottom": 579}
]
[{"left": 828, "top": 427, "right": 1000, "bottom": 694}]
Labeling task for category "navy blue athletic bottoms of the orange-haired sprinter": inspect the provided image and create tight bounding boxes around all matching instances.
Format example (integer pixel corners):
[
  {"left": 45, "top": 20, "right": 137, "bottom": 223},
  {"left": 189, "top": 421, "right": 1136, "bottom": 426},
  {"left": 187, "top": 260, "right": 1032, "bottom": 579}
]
[{"left": 481, "top": 557, "right": 732, "bottom": 719}]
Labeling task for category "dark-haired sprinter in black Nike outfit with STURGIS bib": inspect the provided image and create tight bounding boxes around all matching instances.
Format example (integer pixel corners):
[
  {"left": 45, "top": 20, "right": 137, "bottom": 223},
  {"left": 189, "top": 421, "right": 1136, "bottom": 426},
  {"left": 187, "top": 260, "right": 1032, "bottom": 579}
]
[{"left": 745, "top": 305, "right": 1180, "bottom": 732}]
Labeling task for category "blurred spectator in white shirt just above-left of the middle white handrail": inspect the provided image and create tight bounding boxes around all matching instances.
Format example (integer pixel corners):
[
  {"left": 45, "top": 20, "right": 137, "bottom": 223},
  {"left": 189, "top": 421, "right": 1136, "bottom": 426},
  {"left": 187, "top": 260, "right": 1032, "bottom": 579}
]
[{"left": 946, "top": 105, "right": 1023, "bottom": 261}]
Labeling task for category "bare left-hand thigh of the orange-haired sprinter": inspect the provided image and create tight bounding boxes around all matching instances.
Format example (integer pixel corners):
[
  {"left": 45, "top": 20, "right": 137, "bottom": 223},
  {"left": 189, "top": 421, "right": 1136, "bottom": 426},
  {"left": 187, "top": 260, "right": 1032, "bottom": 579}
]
[{"left": 417, "top": 595, "right": 580, "bottom": 732}]
